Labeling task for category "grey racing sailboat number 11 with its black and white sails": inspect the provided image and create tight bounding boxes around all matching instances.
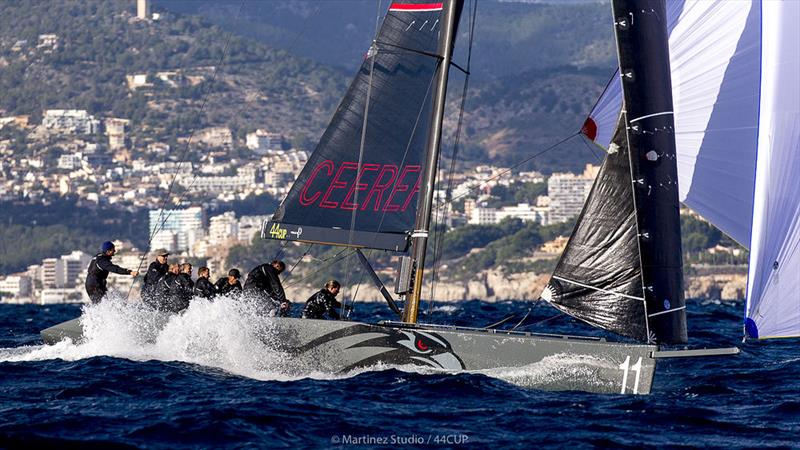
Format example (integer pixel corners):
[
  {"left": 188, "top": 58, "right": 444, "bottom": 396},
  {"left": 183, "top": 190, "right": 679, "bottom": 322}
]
[{"left": 42, "top": 0, "right": 800, "bottom": 394}]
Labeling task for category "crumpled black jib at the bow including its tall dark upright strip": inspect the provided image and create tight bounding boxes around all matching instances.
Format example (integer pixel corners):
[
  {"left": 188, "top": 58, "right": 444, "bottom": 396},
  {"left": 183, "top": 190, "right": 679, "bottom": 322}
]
[{"left": 542, "top": 0, "right": 687, "bottom": 343}]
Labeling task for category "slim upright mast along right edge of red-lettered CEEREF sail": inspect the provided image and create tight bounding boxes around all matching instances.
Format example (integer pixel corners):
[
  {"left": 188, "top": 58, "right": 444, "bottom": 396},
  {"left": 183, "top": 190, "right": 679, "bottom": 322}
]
[{"left": 403, "top": 0, "right": 462, "bottom": 323}]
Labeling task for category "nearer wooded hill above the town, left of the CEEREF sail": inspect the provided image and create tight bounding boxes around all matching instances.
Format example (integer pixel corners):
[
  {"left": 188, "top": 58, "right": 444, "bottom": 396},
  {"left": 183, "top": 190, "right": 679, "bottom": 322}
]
[{"left": 0, "top": 0, "right": 346, "bottom": 145}]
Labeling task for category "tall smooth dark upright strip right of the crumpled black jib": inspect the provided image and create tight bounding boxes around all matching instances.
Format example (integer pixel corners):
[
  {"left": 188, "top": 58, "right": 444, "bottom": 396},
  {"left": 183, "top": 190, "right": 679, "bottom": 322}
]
[{"left": 612, "top": 0, "right": 687, "bottom": 343}]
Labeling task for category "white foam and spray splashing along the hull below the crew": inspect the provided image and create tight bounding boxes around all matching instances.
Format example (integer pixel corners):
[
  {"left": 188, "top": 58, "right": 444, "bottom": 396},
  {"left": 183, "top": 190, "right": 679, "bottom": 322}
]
[{"left": 0, "top": 293, "right": 438, "bottom": 381}]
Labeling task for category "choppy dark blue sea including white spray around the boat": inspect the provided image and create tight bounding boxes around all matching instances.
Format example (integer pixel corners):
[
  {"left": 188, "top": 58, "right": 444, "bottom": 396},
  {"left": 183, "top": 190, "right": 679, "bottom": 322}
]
[{"left": 0, "top": 299, "right": 800, "bottom": 448}]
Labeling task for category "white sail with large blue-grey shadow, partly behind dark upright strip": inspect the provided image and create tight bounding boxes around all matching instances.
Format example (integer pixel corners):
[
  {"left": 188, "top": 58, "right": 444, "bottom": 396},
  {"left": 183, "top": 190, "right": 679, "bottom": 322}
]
[{"left": 590, "top": 0, "right": 761, "bottom": 245}]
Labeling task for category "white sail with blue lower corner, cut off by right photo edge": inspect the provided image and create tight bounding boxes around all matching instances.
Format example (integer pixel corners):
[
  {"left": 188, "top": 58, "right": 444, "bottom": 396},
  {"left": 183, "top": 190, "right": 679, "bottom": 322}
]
[{"left": 746, "top": 0, "right": 800, "bottom": 338}]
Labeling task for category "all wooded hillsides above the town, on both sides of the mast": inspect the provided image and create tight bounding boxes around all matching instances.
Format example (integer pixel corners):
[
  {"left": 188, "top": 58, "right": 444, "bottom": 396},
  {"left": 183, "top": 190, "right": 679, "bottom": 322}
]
[{"left": 0, "top": 0, "right": 611, "bottom": 172}]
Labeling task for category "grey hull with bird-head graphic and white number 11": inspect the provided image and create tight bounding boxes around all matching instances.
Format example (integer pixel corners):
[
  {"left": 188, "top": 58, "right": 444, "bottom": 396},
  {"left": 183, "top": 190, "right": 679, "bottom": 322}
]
[{"left": 41, "top": 318, "right": 658, "bottom": 394}]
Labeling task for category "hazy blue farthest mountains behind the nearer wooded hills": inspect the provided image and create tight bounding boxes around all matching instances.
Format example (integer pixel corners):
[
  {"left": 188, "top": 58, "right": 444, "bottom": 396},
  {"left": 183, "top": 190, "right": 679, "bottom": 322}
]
[{"left": 154, "top": 0, "right": 616, "bottom": 76}]
